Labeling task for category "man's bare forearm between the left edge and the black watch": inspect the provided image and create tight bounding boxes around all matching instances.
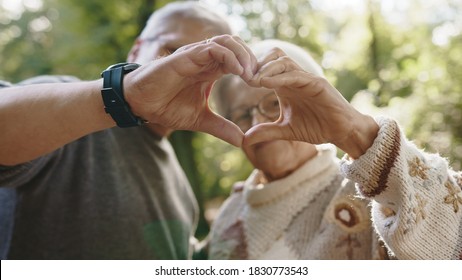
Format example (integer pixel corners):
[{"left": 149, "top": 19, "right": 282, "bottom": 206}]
[{"left": 0, "top": 80, "right": 115, "bottom": 165}]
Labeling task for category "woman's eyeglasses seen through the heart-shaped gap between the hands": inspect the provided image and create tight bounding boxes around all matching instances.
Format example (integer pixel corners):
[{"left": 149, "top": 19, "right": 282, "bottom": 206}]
[{"left": 230, "top": 93, "right": 280, "bottom": 132}]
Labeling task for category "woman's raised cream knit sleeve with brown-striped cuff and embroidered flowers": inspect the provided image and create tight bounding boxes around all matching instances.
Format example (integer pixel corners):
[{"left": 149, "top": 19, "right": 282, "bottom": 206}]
[{"left": 340, "top": 118, "right": 462, "bottom": 259}]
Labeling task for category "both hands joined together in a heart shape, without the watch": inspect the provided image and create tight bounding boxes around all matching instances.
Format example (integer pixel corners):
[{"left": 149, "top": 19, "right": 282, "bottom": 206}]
[{"left": 127, "top": 35, "right": 378, "bottom": 153}]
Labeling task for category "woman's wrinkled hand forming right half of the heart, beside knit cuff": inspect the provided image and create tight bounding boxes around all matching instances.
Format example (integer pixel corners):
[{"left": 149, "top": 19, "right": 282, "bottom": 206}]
[{"left": 243, "top": 49, "right": 378, "bottom": 158}]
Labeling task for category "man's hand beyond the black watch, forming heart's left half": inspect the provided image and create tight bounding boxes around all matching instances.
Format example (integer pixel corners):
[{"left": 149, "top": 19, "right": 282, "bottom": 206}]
[{"left": 124, "top": 35, "right": 257, "bottom": 146}]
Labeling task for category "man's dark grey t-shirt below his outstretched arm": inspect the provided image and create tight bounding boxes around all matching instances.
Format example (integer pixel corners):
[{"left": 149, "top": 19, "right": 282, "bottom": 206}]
[{"left": 0, "top": 77, "right": 198, "bottom": 259}]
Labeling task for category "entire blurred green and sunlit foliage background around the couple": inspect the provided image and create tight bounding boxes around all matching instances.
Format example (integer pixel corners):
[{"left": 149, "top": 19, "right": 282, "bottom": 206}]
[{"left": 0, "top": 0, "right": 462, "bottom": 237}]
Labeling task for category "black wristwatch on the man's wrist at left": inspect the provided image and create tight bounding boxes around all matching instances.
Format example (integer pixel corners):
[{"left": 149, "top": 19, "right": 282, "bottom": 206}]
[{"left": 101, "top": 62, "right": 146, "bottom": 127}]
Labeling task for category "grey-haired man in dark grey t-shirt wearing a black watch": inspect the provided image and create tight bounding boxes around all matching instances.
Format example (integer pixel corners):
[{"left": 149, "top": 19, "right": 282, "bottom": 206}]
[{"left": 0, "top": 2, "right": 256, "bottom": 259}]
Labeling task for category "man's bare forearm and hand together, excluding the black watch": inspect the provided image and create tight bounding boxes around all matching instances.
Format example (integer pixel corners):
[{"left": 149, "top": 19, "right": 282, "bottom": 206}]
[{"left": 0, "top": 35, "right": 256, "bottom": 165}]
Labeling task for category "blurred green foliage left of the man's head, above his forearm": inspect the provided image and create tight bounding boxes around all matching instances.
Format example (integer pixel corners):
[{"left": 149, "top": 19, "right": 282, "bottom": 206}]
[{"left": 0, "top": 0, "right": 159, "bottom": 81}]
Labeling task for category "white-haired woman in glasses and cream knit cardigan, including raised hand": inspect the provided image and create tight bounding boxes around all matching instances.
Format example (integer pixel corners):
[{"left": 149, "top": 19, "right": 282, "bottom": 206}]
[{"left": 209, "top": 40, "right": 462, "bottom": 259}]
